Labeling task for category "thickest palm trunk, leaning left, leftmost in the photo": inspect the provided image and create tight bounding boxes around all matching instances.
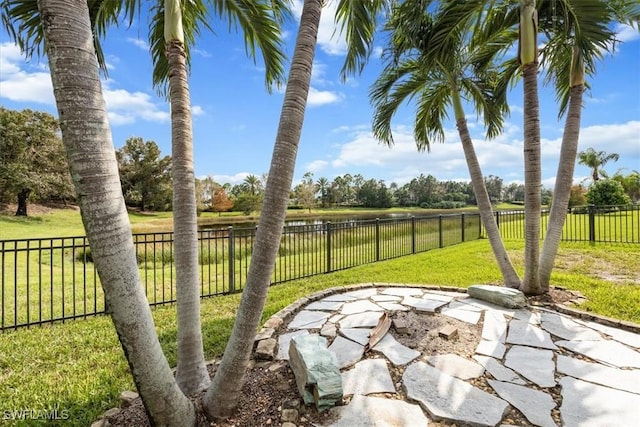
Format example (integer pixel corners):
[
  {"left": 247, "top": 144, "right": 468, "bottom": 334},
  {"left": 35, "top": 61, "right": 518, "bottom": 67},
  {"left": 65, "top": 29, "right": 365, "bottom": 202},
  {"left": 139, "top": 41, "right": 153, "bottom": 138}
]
[{"left": 38, "top": 0, "right": 195, "bottom": 426}]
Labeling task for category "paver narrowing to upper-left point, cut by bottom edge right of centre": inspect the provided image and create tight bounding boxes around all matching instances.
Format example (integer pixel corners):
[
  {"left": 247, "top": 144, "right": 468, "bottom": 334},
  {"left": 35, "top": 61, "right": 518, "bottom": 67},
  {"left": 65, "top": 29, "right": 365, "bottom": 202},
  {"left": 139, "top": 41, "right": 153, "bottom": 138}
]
[{"left": 488, "top": 380, "right": 556, "bottom": 427}]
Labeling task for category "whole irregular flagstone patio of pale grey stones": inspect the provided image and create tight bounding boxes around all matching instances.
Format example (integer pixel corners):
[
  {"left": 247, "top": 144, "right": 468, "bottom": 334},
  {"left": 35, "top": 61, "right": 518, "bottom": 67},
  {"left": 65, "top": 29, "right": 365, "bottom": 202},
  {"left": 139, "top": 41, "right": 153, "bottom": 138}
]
[{"left": 268, "top": 284, "right": 640, "bottom": 427}]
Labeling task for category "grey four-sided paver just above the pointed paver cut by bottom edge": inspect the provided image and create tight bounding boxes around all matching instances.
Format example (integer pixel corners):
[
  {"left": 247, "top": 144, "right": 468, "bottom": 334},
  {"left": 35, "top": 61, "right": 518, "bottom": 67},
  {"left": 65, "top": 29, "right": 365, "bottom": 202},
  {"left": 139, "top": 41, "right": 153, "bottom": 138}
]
[{"left": 504, "top": 345, "right": 556, "bottom": 387}]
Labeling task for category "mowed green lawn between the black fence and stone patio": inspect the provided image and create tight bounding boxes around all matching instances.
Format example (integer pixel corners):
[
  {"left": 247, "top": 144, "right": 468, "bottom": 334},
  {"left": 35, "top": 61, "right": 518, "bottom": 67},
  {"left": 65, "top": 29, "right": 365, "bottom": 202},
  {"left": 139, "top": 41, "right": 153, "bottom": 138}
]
[{"left": 0, "top": 206, "right": 640, "bottom": 426}]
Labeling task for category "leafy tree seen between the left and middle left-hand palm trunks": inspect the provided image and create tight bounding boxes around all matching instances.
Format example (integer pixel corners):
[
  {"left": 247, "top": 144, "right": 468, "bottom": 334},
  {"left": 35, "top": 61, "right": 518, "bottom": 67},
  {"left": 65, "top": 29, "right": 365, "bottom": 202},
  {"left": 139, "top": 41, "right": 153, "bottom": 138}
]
[{"left": 116, "top": 137, "right": 172, "bottom": 211}]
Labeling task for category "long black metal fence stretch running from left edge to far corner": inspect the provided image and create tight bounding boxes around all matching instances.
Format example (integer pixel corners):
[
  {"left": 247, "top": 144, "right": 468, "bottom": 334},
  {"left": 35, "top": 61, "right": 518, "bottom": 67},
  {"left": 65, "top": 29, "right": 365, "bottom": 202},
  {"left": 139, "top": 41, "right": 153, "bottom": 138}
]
[{"left": 0, "top": 213, "right": 482, "bottom": 331}]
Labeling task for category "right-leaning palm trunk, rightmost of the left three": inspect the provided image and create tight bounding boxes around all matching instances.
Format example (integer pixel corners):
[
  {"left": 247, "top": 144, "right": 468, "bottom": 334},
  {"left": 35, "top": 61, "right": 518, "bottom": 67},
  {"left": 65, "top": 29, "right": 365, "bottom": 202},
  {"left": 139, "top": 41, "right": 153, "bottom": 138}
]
[{"left": 203, "top": 0, "right": 323, "bottom": 418}]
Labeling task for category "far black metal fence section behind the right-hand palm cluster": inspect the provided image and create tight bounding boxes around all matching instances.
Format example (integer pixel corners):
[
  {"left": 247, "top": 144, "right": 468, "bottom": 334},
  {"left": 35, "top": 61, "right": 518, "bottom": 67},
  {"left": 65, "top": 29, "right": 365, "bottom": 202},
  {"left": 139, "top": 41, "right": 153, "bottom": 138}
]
[{"left": 495, "top": 205, "right": 640, "bottom": 243}]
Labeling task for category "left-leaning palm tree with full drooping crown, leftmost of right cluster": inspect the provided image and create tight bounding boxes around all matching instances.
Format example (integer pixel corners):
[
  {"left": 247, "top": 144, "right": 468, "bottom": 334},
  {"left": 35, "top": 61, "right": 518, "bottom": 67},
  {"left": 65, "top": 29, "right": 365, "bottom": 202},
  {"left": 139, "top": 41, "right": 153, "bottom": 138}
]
[{"left": 370, "top": 2, "right": 521, "bottom": 288}]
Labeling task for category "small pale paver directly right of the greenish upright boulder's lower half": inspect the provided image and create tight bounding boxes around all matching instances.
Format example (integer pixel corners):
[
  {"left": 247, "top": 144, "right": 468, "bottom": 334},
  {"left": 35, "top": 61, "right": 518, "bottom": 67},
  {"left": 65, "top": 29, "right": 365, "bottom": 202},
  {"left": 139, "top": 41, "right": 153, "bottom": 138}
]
[{"left": 342, "top": 359, "right": 396, "bottom": 396}]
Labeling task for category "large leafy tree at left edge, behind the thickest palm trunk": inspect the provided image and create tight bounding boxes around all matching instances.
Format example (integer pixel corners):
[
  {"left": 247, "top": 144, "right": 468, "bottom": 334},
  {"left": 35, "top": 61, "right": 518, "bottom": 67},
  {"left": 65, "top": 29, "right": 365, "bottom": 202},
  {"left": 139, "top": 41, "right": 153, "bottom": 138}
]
[{"left": 0, "top": 107, "right": 73, "bottom": 216}]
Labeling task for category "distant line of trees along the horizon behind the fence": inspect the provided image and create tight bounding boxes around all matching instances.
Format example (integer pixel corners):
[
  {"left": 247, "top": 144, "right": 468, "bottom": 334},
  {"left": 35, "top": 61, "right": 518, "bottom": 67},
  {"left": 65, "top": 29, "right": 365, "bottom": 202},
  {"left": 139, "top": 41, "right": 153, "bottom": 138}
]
[{"left": 0, "top": 107, "right": 640, "bottom": 215}]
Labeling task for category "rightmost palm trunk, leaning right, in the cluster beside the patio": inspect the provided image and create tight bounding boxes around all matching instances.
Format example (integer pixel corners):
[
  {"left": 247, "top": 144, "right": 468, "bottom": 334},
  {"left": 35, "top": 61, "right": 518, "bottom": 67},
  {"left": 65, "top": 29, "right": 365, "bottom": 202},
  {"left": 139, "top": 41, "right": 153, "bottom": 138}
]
[{"left": 539, "top": 46, "right": 584, "bottom": 292}]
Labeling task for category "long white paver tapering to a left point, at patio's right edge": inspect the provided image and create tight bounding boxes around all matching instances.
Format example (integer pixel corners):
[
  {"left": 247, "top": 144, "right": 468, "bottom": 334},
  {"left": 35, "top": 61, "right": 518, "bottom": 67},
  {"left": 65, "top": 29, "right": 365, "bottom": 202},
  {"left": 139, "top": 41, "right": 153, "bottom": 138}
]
[{"left": 556, "top": 340, "right": 640, "bottom": 368}]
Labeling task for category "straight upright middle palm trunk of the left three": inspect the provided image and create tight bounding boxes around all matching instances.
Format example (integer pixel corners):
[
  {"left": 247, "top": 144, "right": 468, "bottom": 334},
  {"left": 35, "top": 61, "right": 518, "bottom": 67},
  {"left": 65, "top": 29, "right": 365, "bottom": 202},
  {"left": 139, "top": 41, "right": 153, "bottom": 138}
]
[{"left": 164, "top": 0, "right": 210, "bottom": 395}]
